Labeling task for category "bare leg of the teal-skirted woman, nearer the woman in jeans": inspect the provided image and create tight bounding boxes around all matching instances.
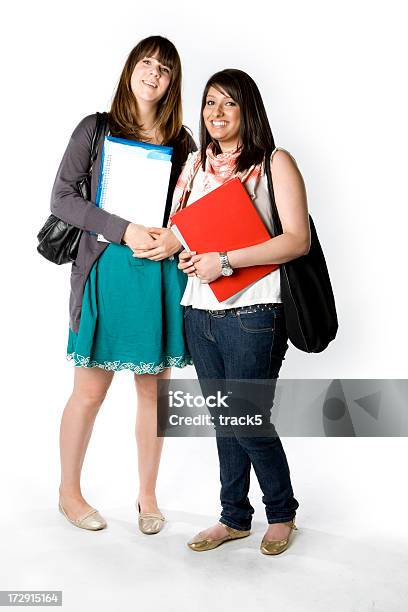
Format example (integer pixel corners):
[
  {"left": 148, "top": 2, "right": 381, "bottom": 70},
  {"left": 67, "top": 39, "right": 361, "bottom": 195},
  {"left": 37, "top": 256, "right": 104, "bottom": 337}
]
[{"left": 135, "top": 368, "right": 170, "bottom": 512}]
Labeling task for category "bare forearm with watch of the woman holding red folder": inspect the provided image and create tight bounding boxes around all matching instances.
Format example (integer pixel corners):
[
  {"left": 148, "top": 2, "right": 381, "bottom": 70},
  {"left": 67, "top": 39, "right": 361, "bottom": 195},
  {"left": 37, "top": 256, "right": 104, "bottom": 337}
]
[{"left": 228, "top": 233, "right": 310, "bottom": 268}]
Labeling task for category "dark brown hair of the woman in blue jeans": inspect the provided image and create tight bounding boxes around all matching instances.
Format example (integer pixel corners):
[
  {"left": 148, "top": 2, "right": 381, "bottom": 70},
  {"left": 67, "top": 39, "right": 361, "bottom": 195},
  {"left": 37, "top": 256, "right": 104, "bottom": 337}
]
[{"left": 200, "top": 68, "right": 275, "bottom": 172}]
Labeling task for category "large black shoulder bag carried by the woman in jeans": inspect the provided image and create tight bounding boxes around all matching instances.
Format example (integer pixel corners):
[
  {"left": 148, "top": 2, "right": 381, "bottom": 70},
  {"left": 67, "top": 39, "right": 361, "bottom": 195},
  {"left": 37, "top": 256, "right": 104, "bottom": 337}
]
[{"left": 265, "top": 155, "right": 338, "bottom": 353}]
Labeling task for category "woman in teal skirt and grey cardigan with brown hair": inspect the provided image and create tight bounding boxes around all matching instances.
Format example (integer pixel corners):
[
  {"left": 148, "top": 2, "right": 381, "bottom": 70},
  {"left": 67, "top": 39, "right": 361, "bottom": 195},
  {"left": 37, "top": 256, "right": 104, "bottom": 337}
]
[{"left": 51, "top": 36, "right": 196, "bottom": 534}]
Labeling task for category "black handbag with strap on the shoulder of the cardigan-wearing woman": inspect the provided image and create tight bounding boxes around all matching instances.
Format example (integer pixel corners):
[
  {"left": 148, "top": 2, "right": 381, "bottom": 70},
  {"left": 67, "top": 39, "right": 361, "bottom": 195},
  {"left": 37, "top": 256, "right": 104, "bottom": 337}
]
[{"left": 37, "top": 113, "right": 108, "bottom": 265}]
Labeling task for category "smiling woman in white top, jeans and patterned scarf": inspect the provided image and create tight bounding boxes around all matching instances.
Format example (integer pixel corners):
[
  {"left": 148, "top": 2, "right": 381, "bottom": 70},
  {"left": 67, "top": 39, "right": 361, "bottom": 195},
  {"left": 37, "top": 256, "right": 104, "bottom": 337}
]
[{"left": 148, "top": 69, "right": 310, "bottom": 555}]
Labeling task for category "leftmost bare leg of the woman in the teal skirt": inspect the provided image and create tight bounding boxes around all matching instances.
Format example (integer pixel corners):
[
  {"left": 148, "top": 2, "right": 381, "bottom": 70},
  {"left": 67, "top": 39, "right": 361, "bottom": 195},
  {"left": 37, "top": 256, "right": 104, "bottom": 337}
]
[{"left": 59, "top": 367, "right": 113, "bottom": 520}]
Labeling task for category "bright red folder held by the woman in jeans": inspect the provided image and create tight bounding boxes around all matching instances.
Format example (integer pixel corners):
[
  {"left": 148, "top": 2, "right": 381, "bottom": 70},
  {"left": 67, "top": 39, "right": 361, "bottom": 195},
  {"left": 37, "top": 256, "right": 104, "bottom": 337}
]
[{"left": 171, "top": 178, "right": 279, "bottom": 302}]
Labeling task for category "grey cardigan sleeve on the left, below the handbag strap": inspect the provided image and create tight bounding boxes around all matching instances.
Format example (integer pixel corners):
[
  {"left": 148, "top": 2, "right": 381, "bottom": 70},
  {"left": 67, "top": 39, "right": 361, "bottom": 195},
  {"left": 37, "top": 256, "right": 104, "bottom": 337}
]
[{"left": 51, "top": 114, "right": 130, "bottom": 243}]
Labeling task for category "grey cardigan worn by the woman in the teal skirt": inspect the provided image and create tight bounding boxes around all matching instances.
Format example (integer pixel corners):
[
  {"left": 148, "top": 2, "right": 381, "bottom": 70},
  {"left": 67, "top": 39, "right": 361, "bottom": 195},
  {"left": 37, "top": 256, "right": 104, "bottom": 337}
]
[{"left": 51, "top": 113, "right": 196, "bottom": 333}]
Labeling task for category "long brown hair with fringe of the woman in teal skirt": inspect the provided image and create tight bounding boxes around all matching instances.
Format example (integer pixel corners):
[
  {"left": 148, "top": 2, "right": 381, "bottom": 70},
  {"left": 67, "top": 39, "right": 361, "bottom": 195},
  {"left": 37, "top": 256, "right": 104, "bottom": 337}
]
[{"left": 109, "top": 36, "right": 183, "bottom": 144}]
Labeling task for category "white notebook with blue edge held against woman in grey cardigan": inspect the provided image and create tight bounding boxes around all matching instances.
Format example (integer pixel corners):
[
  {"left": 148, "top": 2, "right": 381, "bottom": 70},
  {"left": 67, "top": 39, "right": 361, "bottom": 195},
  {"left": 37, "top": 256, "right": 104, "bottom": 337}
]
[{"left": 96, "top": 136, "right": 173, "bottom": 242}]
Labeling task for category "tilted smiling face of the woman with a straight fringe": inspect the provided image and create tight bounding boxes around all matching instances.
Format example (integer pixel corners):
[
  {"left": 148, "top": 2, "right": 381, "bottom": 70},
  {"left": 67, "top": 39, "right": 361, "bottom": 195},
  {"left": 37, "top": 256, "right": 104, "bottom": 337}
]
[{"left": 130, "top": 53, "right": 171, "bottom": 106}]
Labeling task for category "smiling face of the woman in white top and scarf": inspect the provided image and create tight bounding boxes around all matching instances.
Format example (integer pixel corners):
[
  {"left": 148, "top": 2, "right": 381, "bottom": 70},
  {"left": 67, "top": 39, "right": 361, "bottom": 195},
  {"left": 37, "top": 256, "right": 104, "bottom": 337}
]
[{"left": 203, "top": 87, "right": 241, "bottom": 152}]
